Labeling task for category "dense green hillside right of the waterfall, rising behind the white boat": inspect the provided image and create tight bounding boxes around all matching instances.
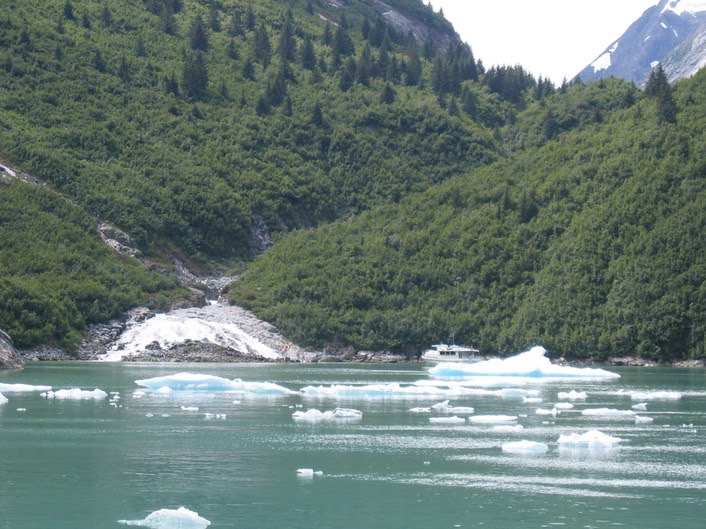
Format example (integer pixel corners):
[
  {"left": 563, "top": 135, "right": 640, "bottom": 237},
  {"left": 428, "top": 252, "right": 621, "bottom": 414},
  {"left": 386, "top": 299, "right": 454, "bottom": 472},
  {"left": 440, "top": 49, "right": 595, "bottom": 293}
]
[{"left": 231, "top": 70, "right": 706, "bottom": 360}]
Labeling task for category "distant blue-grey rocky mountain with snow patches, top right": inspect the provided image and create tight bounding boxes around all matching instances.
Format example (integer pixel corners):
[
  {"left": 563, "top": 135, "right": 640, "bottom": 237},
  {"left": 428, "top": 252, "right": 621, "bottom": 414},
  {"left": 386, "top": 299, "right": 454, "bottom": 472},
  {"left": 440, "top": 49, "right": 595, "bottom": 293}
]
[{"left": 577, "top": 0, "right": 706, "bottom": 86}]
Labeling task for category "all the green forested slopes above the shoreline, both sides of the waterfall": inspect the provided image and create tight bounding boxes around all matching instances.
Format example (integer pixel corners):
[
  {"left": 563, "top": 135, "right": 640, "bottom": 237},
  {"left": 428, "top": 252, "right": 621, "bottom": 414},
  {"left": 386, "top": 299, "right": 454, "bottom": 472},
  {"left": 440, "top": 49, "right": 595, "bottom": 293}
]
[{"left": 0, "top": 0, "right": 704, "bottom": 364}]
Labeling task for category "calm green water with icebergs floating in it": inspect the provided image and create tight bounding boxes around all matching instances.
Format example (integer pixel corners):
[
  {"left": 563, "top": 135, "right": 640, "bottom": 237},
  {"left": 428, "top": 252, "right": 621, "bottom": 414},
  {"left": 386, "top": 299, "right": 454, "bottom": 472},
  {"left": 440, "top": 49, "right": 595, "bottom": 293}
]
[{"left": 0, "top": 363, "right": 706, "bottom": 529}]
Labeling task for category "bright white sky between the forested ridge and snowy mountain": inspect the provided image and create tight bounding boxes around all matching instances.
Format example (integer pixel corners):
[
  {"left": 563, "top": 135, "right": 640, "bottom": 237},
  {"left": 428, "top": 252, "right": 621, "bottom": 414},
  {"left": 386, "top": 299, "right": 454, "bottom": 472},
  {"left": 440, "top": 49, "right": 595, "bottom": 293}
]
[{"left": 431, "top": 0, "right": 658, "bottom": 85}]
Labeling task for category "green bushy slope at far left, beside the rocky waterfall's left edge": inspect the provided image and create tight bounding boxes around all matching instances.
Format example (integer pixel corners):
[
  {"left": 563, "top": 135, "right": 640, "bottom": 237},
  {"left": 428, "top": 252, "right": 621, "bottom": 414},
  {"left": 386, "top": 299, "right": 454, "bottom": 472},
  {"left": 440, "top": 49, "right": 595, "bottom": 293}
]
[{"left": 0, "top": 177, "right": 180, "bottom": 350}]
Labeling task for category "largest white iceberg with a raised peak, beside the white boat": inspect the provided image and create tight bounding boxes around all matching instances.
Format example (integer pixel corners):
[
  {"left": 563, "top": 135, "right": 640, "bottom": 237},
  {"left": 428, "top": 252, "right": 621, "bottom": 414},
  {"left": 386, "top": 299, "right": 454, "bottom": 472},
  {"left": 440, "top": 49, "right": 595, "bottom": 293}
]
[{"left": 429, "top": 346, "right": 620, "bottom": 380}]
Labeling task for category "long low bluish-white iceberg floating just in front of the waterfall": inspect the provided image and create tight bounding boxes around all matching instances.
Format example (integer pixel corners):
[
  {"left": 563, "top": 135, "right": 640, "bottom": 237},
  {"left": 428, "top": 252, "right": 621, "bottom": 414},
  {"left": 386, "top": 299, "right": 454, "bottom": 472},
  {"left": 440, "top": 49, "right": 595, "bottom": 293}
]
[{"left": 135, "top": 373, "right": 295, "bottom": 395}]
